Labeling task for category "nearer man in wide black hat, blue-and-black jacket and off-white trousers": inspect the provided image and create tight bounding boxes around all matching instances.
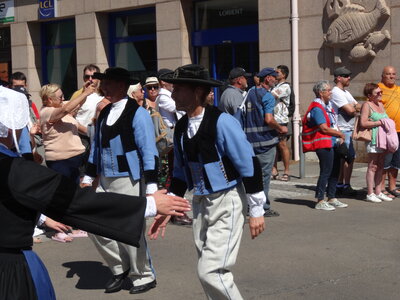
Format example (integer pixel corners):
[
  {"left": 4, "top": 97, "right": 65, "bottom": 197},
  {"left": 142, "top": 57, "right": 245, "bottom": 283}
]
[{"left": 151, "top": 65, "right": 265, "bottom": 299}]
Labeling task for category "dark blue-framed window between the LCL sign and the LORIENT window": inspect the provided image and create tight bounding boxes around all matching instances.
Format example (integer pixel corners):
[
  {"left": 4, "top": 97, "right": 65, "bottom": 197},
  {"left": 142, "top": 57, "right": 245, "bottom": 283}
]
[{"left": 109, "top": 7, "right": 157, "bottom": 78}]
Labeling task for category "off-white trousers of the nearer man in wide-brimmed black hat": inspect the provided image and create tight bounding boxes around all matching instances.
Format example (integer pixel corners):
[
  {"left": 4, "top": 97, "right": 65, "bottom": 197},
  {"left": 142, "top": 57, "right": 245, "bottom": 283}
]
[{"left": 192, "top": 185, "right": 247, "bottom": 300}]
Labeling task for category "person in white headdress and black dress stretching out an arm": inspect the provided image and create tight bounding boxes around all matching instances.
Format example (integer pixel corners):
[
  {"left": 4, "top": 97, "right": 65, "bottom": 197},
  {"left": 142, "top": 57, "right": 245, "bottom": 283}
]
[{"left": 0, "top": 87, "right": 189, "bottom": 300}]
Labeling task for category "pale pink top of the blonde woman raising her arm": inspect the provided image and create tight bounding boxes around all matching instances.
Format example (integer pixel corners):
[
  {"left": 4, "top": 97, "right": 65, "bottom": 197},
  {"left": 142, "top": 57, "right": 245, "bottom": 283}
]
[{"left": 40, "top": 107, "right": 85, "bottom": 160}]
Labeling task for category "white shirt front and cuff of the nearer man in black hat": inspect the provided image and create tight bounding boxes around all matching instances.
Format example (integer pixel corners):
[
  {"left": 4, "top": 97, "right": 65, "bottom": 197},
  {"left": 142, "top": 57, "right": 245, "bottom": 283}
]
[{"left": 187, "top": 108, "right": 266, "bottom": 217}]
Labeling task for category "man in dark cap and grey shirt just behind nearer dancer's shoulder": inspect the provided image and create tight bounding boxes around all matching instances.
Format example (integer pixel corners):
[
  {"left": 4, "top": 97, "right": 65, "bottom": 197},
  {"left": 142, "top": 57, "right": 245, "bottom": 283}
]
[{"left": 218, "top": 67, "right": 251, "bottom": 115}]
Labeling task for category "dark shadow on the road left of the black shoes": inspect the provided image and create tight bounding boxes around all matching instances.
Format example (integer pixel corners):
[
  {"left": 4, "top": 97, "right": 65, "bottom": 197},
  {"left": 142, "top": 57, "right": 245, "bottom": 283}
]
[{"left": 62, "top": 261, "right": 131, "bottom": 290}]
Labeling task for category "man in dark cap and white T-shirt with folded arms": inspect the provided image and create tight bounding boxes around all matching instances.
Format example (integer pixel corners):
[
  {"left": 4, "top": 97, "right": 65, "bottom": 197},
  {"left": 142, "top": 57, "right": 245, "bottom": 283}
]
[{"left": 330, "top": 67, "right": 361, "bottom": 198}]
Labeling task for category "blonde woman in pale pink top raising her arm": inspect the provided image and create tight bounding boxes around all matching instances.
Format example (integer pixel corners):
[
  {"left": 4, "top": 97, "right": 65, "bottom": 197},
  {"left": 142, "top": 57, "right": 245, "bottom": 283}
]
[{"left": 40, "top": 82, "right": 95, "bottom": 183}]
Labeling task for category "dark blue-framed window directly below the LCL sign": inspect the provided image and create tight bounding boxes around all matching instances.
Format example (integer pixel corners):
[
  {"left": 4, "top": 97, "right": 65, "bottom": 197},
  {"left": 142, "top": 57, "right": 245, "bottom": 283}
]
[{"left": 41, "top": 19, "right": 77, "bottom": 99}]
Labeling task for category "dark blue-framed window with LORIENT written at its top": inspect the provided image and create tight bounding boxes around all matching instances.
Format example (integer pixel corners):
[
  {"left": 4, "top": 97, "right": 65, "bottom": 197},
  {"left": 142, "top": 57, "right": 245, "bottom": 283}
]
[{"left": 192, "top": 0, "right": 259, "bottom": 104}]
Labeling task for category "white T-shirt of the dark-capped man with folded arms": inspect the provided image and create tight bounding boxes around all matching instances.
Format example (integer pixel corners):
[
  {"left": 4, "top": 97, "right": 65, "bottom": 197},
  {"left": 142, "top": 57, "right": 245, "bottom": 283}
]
[{"left": 330, "top": 86, "right": 357, "bottom": 131}]
